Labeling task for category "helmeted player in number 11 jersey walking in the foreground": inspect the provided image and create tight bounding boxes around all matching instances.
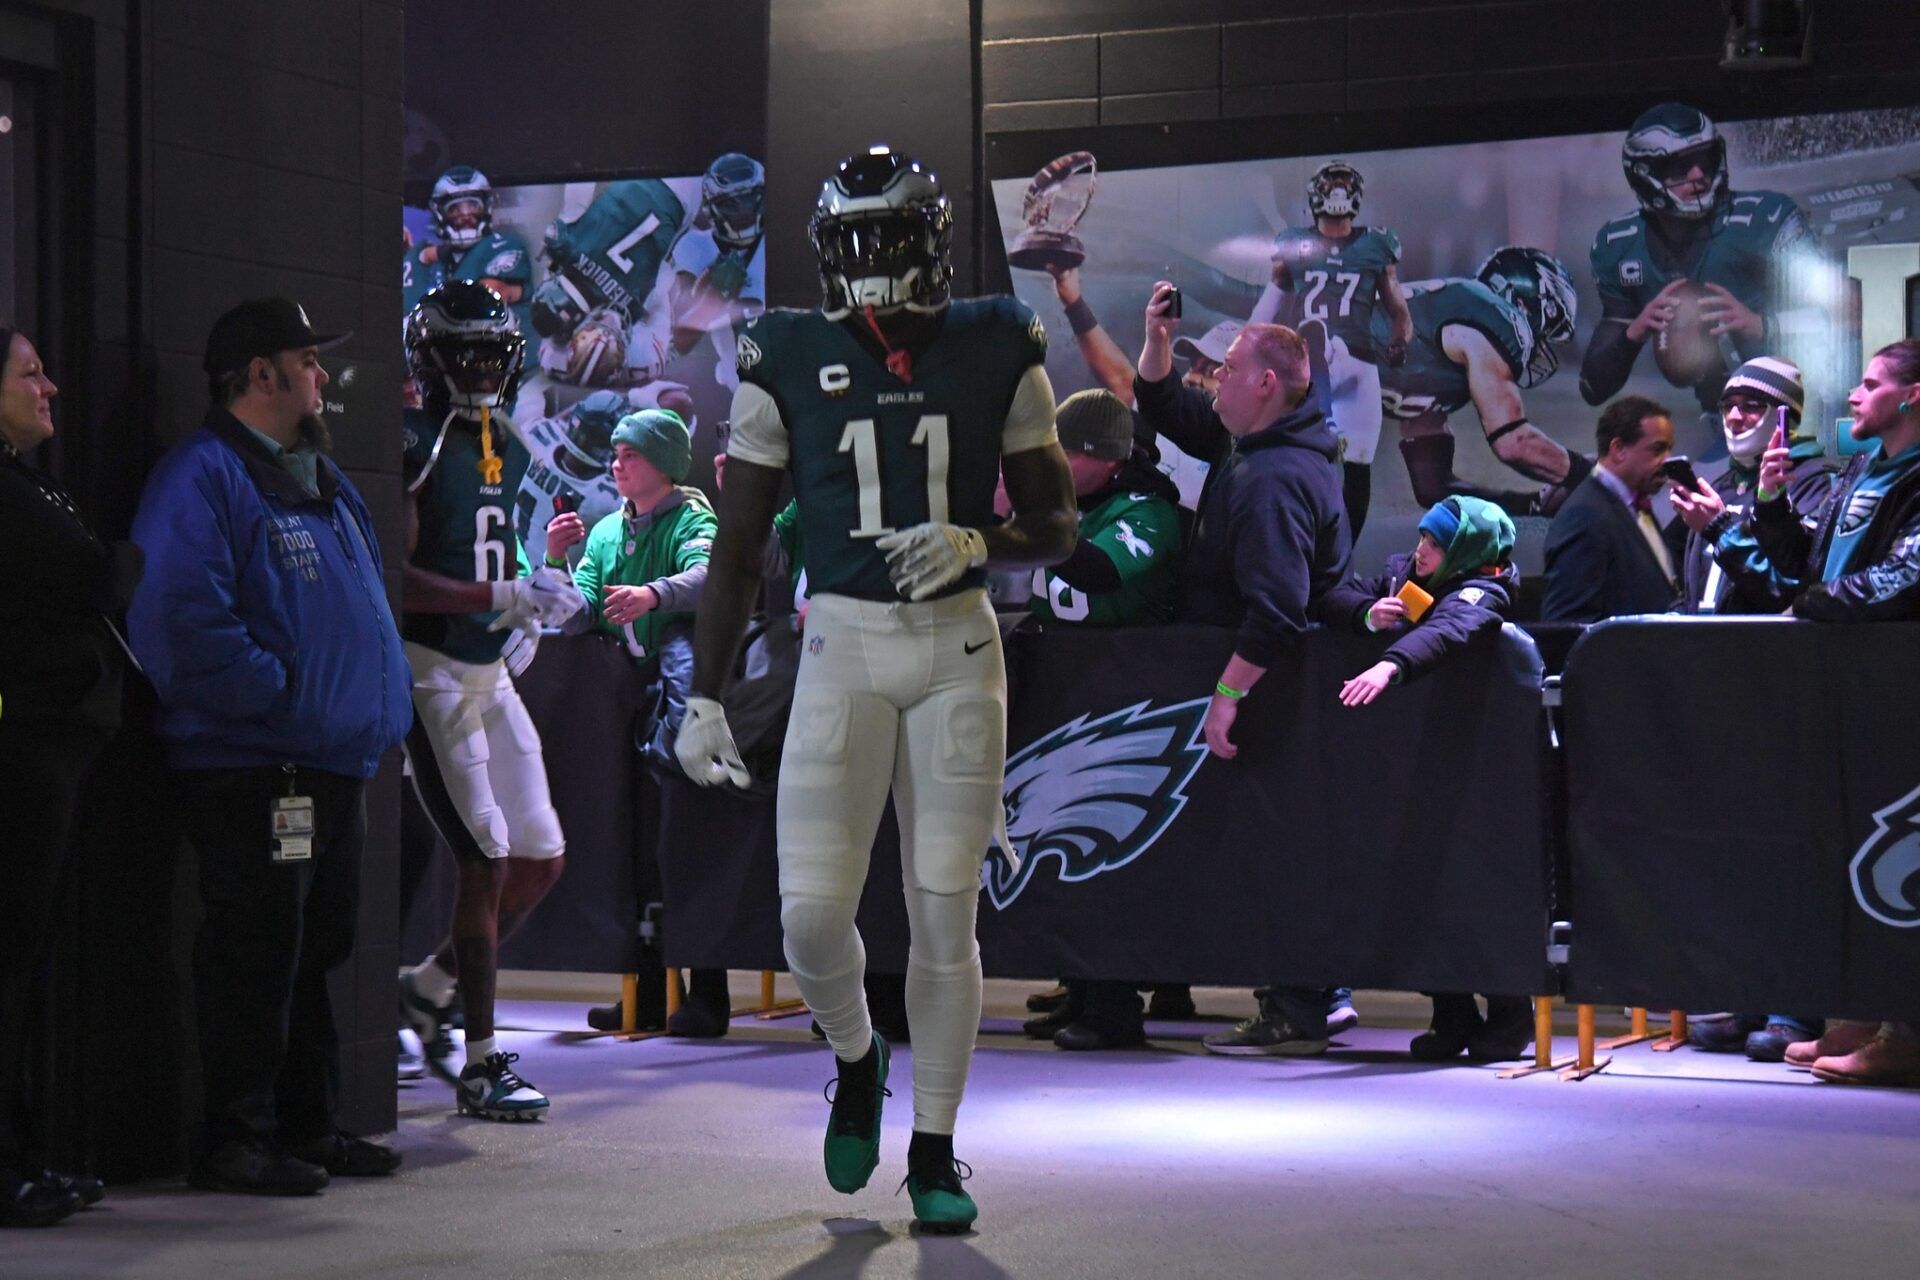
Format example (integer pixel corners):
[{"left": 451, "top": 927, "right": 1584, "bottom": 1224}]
[{"left": 676, "top": 148, "right": 1075, "bottom": 1232}]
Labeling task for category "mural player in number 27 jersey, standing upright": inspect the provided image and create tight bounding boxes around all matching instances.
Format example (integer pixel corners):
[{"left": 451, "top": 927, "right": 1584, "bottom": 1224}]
[{"left": 1248, "top": 159, "right": 1413, "bottom": 537}]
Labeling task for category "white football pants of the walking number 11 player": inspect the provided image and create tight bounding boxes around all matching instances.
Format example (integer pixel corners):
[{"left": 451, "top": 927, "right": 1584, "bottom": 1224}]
[{"left": 776, "top": 591, "right": 1006, "bottom": 1134}]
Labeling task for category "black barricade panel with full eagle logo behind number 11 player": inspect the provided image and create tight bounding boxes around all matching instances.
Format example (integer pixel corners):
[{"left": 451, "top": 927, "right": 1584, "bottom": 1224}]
[{"left": 660, "top": 628, "right": 1546, "bottom": 994}]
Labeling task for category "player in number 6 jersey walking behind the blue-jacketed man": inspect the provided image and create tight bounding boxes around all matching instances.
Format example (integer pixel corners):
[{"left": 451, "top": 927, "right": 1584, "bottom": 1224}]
[{"left": 401, "top": 280, "right": 586, "bottom": 1121}]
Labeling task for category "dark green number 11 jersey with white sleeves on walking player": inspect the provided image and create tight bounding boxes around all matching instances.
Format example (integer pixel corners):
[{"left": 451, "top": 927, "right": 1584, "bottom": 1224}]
[{"left": 728, "top": 297, "right": 1054, "bottom": 601}]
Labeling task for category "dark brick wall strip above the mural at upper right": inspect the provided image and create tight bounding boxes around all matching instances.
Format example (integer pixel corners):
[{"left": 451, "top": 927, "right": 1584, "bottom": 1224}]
[{"left": 981, "top": 0, "right": 1920, "bottom": 132}]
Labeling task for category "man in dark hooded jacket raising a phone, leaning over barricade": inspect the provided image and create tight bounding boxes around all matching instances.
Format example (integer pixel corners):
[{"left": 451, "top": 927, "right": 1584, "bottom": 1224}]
[{"left": 1133, "top": 280, "right": 1354, "bottom": 1055}]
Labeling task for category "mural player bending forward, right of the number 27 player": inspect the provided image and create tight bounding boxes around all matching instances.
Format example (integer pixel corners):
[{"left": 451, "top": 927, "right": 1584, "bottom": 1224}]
[{"left": 1375, "top": 246, "right": 1592, "bottom": 516}]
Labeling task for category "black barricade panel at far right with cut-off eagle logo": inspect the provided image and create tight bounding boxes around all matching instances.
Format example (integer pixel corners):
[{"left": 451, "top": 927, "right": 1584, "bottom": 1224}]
[{"left": 1565, "top": 618, "right": 1920, "bottom": 1019}]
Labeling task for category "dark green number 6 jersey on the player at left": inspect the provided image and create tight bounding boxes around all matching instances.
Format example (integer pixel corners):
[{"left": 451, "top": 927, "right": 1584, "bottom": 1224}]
[{"left": 399, "top": 409, "right": 528, "bottom": 662}]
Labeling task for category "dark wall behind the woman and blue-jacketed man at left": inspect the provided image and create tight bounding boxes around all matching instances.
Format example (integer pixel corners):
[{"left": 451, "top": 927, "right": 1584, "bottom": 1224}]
[{"left": 0, "top": 0, "right": 403, "bottom": 1176}]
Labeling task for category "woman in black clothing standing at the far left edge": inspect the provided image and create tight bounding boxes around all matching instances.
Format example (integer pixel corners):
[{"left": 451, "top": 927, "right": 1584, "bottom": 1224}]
[{"left": 0, "top": 320, "right": 140, "bottom": 1226}]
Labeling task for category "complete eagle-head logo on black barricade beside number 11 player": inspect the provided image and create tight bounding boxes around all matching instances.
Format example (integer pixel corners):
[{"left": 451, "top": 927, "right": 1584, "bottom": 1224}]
[{"left": 981, "top": 699, "right": 1208, "bottom": 912}]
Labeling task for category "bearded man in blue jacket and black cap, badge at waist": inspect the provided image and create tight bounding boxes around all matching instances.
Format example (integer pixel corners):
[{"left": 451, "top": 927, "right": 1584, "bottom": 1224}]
[{"left": 129, "top": 297, "right": 413, "bottom": 1196}]
